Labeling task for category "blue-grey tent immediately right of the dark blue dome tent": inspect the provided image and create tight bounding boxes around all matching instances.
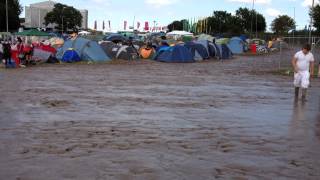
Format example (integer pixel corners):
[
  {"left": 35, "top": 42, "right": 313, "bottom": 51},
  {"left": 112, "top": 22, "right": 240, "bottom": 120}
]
[{"left": 184, "top": 42, "right": 209, "bottom": 61}]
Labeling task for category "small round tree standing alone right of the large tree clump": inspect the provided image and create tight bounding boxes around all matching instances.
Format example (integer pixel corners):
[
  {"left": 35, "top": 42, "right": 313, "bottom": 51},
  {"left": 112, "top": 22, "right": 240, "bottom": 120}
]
[{"left": 271, "top": 15, "right": 296, "bottom": 35}]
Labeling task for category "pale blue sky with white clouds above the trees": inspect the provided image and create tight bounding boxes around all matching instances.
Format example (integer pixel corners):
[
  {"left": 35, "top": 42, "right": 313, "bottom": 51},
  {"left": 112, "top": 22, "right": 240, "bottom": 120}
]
[{"left": 20, "top": 0, "right": 319, "bottom": 31}]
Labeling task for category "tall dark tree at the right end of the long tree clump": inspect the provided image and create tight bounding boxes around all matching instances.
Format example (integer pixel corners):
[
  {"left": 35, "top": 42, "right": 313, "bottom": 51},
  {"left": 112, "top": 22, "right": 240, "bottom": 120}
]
[{"left": 236, "top": 8, "right": 267, "bottom": 33}]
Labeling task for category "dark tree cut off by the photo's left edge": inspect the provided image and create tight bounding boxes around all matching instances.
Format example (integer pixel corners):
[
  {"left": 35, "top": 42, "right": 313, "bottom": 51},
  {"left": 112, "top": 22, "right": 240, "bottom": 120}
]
[{"left": 0, "top": 0, "right": 22, "bottom": 31}]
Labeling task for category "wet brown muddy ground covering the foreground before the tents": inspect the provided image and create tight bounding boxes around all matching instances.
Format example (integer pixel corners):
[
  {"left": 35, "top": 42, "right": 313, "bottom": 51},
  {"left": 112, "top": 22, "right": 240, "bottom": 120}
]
[{"left": 0, "top": 49, "right": 320, "bottom": 180}]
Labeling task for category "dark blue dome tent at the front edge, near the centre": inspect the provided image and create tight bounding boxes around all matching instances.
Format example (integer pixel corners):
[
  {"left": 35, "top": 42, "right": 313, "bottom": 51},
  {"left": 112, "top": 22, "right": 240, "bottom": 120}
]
[{"left": 154, "top": 45, "right": 195, "bottom": 63}]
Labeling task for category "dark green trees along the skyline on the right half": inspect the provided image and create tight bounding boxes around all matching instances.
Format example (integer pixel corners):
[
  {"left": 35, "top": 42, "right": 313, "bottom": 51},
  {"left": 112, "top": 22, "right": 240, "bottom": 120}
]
[{"left": 168, "top": 5, "right": 320, "bottom": 36}]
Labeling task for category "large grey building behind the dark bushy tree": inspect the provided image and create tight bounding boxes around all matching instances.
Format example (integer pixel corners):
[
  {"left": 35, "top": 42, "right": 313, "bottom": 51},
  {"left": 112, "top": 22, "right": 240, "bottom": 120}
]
[{"left": 24, "top": 0, "right": 88, "bottom": 29}]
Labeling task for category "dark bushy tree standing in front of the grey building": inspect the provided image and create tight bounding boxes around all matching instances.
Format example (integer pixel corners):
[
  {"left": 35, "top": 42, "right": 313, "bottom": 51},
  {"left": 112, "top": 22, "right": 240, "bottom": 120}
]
[{"left": 44, "top": 3, "right": 82, "bottom": 31}]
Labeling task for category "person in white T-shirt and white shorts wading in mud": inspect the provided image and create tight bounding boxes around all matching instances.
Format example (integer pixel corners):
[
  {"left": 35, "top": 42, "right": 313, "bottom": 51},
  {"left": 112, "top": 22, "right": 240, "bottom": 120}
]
[{"left": 292, "top": 44, "right": 314, "bottom": 101}]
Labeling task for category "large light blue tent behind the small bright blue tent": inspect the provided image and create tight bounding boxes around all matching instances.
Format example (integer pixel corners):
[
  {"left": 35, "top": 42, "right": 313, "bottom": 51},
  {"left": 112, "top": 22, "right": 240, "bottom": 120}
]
[{"left": 57, "top": 37, "right": 111, "bottom": 62}]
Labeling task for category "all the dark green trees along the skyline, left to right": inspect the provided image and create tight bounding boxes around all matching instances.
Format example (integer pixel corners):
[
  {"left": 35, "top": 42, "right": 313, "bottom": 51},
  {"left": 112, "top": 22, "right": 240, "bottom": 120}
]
[{"left": 0, "top": 0, "right": 320, "bottom": 35}]
